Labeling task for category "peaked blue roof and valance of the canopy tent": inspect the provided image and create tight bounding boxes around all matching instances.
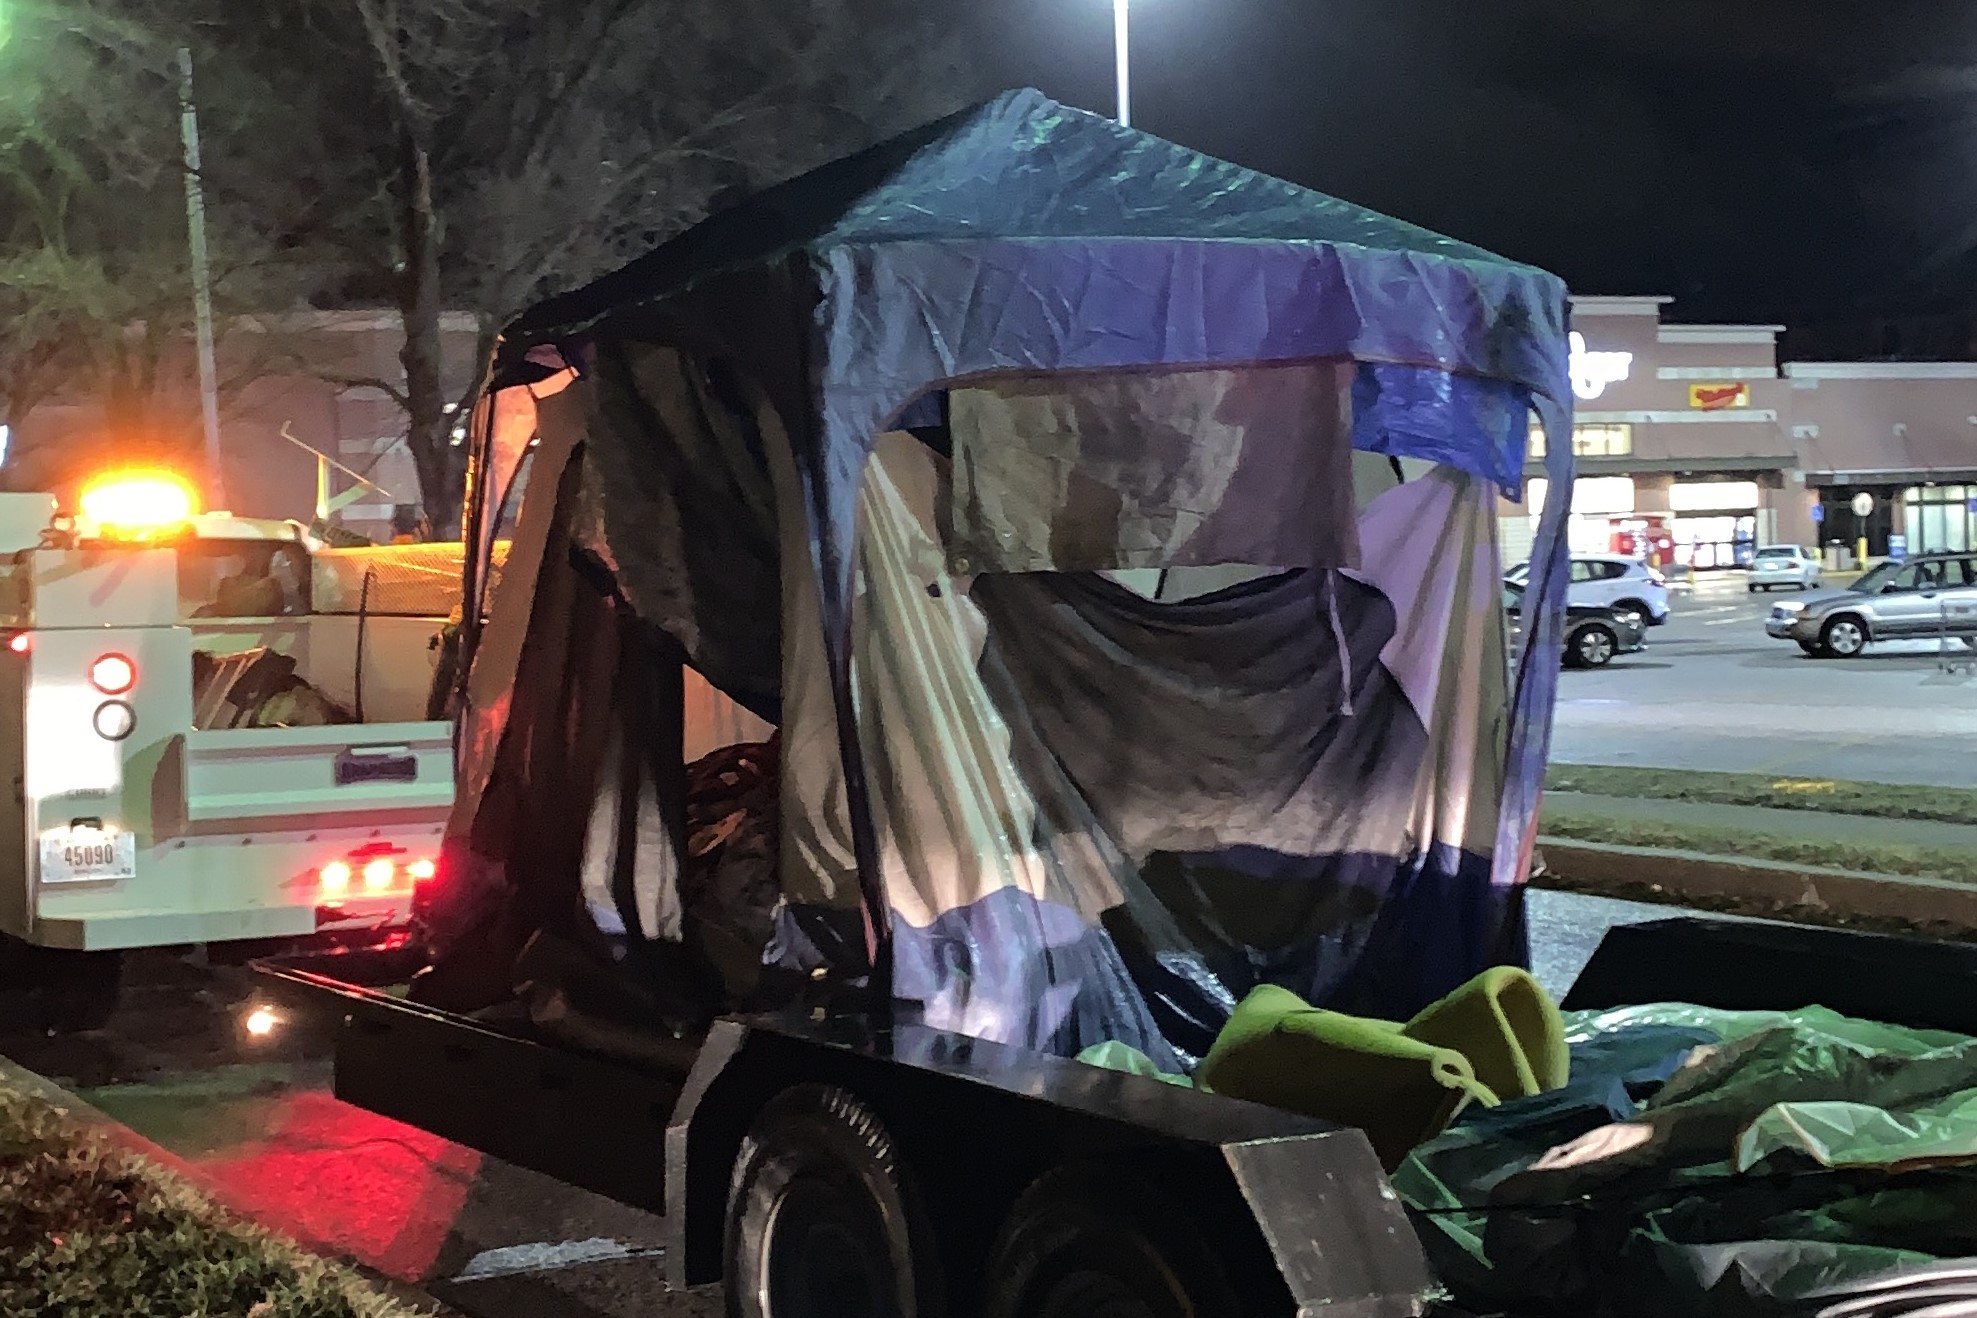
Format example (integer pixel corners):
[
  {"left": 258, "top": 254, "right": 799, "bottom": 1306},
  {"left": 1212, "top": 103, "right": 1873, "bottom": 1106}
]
[{"left": 504, "top": 91, "right": 1570, "bottom": 474}]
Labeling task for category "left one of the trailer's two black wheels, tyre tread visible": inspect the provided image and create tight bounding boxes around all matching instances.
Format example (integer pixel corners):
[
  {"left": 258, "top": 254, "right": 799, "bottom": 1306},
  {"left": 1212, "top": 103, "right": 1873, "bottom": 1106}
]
[{"left": 724, "top": 1085, "right": 943, "bottom": 1318}]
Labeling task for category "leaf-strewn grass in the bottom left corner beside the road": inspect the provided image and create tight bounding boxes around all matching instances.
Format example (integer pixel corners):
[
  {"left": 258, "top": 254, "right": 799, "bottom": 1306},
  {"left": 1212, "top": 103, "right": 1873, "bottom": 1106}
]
[{"left": 0, "top": 1081, "right": 430, "bottom": 1318}]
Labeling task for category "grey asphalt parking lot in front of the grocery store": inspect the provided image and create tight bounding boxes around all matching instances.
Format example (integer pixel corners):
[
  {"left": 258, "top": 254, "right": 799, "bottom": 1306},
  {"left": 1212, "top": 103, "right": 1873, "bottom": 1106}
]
[{"left": 1552, "top": 575, "right": 1977, "bottom": 786}]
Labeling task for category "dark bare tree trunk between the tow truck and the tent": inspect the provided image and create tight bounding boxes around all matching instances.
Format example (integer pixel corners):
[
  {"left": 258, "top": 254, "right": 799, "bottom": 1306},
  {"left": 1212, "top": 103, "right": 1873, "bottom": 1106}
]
[{"left": 397, "top": 132, "right": 467, "bottom": 539}]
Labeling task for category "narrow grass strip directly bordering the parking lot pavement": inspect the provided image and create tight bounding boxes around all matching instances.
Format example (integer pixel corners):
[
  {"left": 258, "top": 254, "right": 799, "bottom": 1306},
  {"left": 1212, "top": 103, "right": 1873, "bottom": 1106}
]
[{"left": 1544, "top": 765, "right": 1977, "bottom": 824}]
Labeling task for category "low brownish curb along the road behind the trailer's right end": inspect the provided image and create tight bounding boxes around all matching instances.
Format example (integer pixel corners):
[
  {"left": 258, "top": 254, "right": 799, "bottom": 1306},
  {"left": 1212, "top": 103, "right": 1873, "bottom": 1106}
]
[{"left": 1532, "top": 834, "right": 1977, "bottom": 933}]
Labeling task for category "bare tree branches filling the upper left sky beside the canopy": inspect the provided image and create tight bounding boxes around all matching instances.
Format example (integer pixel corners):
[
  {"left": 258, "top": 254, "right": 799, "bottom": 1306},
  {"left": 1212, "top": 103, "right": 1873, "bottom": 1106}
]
[{"left": 11, "top": 0, "right": 985, "bottom": 528}]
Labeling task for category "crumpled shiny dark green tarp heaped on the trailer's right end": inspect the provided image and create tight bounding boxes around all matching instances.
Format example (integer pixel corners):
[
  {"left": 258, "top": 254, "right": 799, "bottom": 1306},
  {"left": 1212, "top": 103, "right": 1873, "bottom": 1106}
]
[{"left": 1394, "top": 1004, "right": 1977, "bottom": 1318}]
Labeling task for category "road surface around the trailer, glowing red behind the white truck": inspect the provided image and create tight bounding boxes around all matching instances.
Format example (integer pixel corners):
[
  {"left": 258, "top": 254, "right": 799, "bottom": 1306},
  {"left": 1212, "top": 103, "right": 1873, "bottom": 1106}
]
[{"left": 0, "top": 893, "right": 1669, "bottom": 1318}]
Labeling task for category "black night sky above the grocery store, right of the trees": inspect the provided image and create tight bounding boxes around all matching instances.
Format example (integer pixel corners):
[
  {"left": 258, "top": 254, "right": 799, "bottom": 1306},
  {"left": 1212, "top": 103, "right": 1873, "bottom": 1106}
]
[{"left": 985, "top": 0, "right": 1977, "bottom": 322}]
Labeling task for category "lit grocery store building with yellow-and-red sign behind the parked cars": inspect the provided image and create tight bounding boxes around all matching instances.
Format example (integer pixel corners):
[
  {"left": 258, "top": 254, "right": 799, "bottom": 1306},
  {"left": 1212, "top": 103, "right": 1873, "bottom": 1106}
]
[{"left": 1501, "top": 296, "right": 1977, "bottom": 569}]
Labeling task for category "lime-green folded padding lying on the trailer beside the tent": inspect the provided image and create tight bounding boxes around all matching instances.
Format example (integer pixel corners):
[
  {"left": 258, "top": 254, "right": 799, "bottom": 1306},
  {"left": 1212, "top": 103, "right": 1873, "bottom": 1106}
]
[{"left": 1079, "top": 966, "right": 1570, "bottom": 1168}]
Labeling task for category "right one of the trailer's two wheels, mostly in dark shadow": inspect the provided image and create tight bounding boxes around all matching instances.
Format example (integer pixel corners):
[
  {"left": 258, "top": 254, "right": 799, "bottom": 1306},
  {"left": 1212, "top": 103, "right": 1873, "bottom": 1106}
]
[{"left": 983, "top": 1166, "right": 1240, "bottom": 1318}]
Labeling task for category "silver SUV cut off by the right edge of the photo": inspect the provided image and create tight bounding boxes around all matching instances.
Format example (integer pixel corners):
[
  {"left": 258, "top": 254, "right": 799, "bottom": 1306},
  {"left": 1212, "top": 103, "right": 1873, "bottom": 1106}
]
[{"left": 1763, "top": 553, "right": 1977, "bottom": 658}]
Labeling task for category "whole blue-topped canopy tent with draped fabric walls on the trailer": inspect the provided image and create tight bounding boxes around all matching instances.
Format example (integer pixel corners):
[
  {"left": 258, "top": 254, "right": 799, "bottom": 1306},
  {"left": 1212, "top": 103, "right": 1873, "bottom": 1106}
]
[{"left": 417, "top": 91, "right": 1572, "bottom": 1067}]
